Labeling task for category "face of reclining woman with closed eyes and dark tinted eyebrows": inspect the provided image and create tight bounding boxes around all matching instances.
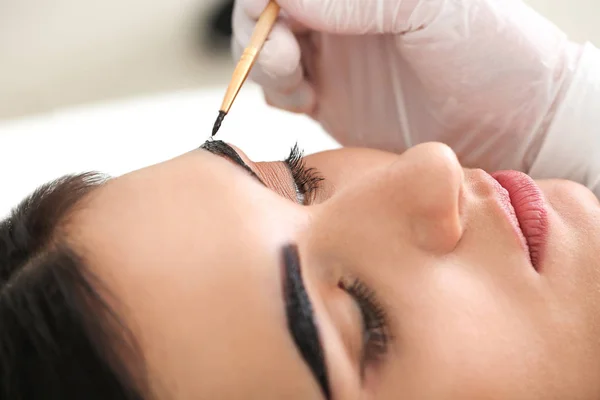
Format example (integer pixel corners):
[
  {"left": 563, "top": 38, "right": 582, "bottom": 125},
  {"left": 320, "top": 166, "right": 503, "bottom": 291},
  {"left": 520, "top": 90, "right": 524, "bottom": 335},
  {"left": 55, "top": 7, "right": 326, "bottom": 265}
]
[{"left": 73, "top": 142, "right": 600, "bottom": 400}]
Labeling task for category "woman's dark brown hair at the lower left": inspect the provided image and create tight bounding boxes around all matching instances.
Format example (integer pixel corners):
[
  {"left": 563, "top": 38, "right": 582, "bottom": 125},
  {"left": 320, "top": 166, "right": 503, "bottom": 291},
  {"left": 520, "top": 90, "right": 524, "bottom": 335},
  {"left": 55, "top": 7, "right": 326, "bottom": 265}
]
[{"left": 0, "top": 173, "right": 142, "bottom": 400}]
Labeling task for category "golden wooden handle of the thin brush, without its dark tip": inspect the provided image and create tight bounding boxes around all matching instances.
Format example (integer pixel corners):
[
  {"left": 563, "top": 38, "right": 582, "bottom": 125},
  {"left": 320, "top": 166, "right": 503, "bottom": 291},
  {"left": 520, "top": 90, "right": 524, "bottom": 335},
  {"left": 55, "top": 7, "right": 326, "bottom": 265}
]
[{"left": 221, "top": 1, "right": 280, "bottom": 113}]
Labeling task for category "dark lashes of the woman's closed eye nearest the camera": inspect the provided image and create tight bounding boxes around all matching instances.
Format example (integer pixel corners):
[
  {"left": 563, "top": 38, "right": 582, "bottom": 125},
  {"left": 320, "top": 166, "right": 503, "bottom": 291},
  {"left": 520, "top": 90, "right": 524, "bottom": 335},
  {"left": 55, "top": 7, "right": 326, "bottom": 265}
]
[{"left": 338, "top": 279, "right": 390, "bottom": 369}]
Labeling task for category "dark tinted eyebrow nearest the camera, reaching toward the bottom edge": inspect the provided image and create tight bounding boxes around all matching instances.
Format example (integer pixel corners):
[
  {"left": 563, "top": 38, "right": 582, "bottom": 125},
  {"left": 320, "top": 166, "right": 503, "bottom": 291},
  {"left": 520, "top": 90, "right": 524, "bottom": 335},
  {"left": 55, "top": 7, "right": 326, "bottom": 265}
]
[{"left": 282, "top": 245, "right": 331, "bottom": 400}]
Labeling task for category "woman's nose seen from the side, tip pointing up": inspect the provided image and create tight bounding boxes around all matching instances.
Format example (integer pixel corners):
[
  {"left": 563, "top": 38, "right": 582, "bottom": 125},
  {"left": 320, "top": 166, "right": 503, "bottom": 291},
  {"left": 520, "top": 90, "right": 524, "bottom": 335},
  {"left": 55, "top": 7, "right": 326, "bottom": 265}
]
[{"left": 330, "top": 143, "right": 464, "bottom": 254}]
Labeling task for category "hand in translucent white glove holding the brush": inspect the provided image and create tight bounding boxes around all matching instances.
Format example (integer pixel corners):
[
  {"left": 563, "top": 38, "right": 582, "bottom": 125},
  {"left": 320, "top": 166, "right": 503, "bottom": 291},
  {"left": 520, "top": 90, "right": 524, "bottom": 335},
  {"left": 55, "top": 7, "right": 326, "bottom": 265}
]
[{"left": 233, "top": 0, "right": 581, "bottom": 172}]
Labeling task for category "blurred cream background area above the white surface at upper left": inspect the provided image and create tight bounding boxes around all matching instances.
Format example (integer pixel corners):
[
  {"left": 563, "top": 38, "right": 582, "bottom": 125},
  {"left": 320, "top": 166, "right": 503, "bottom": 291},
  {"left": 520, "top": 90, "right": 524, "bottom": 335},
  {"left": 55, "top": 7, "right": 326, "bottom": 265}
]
[{"left": 0, "top": 0, "right": 231, "bottom": 118}]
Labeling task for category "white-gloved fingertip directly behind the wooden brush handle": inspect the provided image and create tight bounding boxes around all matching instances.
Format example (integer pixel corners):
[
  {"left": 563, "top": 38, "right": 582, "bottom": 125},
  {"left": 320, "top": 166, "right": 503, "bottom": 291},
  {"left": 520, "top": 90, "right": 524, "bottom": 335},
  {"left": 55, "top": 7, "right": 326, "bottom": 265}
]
[{"left": 232, "top": 0, "right": 303, "bottom": 92}]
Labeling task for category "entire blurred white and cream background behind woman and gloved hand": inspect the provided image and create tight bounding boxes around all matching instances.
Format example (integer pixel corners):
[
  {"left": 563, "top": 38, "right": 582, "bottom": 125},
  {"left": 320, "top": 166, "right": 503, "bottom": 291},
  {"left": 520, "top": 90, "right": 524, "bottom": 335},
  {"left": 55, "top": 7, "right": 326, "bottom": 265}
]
[{"left": 0, "top": 0, "right": 600, "bottom": 216}]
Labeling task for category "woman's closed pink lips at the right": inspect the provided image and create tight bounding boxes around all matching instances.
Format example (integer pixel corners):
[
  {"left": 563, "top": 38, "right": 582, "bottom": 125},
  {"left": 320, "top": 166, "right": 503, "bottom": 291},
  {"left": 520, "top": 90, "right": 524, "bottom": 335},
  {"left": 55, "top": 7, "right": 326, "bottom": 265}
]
[{"left": 492, "top": 171, "right": 548, "bottom": 271}]
